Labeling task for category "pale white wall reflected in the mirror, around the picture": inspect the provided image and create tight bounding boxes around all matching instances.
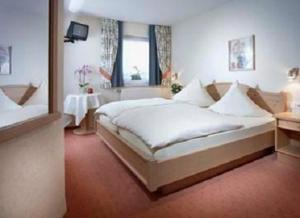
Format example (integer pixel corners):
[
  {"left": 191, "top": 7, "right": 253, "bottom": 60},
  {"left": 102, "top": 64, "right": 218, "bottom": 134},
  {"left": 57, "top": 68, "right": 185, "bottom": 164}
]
[{"left": 0, "top": 5, "right": 48, "bottom": 85}]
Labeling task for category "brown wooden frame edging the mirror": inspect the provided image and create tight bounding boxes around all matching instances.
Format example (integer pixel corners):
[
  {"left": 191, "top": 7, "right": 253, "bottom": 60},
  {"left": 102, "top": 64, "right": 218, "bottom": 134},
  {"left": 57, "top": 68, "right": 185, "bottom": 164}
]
[{"left": 0, "top": 0, "right": 61, "bottom": 143}]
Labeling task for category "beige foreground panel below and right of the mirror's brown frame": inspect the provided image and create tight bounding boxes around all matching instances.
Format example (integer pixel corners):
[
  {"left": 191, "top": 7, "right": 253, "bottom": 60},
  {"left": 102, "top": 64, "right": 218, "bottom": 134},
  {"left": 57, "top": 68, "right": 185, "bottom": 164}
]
[{"left": 0, "top": 1, "right": 66, "bottom": 218}]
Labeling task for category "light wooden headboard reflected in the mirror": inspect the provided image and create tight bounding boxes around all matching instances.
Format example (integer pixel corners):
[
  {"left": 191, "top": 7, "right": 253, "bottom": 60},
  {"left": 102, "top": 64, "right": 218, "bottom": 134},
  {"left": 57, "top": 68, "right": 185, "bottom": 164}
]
[{"left": 0, "top": 85, "right": 37, "bottom": 105}]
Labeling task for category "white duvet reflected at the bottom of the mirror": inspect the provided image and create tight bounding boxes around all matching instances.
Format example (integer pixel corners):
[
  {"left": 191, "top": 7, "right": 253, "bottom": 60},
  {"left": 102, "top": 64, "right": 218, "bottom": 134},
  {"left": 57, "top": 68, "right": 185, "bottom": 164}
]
[{"left": 0, "top": 105, "right": 48, "bottom": 128}]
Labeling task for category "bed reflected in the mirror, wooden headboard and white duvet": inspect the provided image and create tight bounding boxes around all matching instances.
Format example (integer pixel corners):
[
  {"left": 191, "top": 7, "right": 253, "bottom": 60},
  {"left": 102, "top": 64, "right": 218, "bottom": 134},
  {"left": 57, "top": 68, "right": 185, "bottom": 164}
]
[{"left": 0, "top": 85, "right": 48, "bottom": 128}]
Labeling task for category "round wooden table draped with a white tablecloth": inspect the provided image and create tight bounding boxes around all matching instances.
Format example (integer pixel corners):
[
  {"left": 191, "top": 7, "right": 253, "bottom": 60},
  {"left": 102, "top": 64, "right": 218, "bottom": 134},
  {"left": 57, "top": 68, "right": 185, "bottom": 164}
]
[{"left": 64, "top": 93, "right": 102, "bottom": 135}]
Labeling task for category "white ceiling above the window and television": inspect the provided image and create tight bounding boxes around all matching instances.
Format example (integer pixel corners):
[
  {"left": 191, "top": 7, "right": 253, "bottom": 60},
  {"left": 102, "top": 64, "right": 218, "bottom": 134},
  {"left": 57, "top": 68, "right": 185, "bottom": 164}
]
[{"left": 65, "top": 0, "right": 229, "bottom": 25}]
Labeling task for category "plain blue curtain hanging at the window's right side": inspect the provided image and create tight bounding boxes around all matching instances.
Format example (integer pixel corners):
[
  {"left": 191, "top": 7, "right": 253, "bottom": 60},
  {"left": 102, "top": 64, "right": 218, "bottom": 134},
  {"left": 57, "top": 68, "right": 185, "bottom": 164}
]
[{"left": 149, "top": 25, "right": 162, "bottom": 86}]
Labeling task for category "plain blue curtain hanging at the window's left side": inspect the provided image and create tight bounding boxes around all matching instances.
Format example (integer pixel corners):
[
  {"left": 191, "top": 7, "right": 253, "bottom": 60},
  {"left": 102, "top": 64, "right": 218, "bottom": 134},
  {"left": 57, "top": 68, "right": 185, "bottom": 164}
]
[{"left": 111, "top": 21, "right": 124, "bottom": 87}]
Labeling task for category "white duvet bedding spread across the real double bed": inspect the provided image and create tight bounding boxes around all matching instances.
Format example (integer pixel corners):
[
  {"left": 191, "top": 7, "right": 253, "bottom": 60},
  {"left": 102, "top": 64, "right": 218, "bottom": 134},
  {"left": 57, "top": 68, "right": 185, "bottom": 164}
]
[{"left": 98, "top": 99, "right": 242, "bottom": 149}]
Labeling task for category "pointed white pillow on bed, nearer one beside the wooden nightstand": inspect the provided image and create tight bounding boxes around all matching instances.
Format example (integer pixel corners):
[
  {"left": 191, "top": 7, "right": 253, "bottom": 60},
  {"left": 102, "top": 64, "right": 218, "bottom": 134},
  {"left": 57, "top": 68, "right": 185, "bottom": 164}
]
[{"left": 210, "top": 83, "right": 272, "bottom": 117}]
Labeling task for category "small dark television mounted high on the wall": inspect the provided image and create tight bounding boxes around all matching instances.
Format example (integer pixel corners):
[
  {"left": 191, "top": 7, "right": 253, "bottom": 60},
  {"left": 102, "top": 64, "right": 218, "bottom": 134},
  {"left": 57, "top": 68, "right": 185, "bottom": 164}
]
[{"left": 67, "top": 21, "right": 89, "bottom": 41}]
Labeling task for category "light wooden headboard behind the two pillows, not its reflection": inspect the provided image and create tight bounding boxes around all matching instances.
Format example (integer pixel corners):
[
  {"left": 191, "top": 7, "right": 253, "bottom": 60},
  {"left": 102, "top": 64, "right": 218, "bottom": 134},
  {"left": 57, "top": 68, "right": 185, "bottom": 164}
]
[{"left": 206, "top": 83, "right": 287, "bottom": 114}]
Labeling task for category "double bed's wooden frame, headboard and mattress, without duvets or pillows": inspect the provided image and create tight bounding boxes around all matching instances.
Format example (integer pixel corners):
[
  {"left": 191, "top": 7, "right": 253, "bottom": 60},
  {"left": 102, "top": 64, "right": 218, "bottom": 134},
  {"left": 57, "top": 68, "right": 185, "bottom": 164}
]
[{"left": 97, "top": 83, "right": 286, "bottom": 194}]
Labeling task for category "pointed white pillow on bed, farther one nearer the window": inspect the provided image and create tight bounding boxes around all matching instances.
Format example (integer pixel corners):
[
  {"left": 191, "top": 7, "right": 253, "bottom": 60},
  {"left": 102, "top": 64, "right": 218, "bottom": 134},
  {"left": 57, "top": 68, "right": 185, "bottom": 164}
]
[{"left": 173, "top": 79, "right": 215, "bottom": 107}]
